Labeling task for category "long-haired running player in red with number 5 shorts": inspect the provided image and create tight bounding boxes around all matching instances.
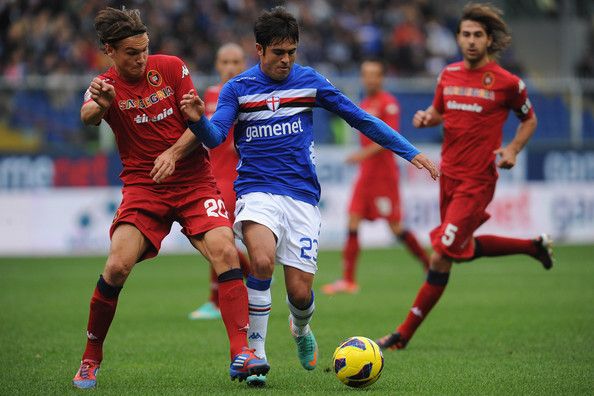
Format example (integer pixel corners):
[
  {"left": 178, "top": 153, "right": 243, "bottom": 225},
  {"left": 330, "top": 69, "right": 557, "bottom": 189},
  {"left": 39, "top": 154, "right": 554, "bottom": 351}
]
[{"left": 378, "top": 4, "right": 553, "bottom": 349}]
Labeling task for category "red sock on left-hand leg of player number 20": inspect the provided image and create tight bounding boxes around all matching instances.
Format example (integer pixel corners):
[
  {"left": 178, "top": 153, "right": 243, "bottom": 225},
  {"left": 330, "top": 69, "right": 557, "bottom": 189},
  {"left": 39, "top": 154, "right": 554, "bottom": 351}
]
[{"left": 82, "top": 276, "right": 122, "bottom": 362}]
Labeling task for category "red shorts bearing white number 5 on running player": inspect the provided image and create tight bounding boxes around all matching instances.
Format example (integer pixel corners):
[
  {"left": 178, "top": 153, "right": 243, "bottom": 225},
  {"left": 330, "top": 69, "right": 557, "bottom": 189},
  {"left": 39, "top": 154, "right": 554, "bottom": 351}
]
[{"left": 429, "top": 175, "right": 495, "bottom": 259}]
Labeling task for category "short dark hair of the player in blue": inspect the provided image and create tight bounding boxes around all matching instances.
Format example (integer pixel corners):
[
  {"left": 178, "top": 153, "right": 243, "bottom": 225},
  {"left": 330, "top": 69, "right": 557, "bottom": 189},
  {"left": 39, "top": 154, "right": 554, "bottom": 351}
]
[{"left": 254, "top": 6, "right": 299, "bottom": 50}]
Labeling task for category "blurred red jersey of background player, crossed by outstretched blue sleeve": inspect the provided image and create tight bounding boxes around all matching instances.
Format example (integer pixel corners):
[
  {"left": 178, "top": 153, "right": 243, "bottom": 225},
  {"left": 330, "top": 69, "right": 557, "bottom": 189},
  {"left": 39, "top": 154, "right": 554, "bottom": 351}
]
[{"left": 359, "top": 91, "right": 400, "bottom": 183}]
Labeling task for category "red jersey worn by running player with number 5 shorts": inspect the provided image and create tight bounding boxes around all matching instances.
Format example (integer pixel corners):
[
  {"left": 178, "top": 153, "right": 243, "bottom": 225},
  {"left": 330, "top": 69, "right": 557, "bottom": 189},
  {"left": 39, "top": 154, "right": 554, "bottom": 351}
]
[{"left": 433, "top": 62, "right": 534, "bottom": 182}]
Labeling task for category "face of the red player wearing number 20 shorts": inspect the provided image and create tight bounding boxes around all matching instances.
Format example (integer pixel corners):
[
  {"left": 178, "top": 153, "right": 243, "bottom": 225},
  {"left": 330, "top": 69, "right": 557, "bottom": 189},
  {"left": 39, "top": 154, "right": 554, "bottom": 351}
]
[{"left": 106, "top": 33, "right": 149, "bottom": 81}]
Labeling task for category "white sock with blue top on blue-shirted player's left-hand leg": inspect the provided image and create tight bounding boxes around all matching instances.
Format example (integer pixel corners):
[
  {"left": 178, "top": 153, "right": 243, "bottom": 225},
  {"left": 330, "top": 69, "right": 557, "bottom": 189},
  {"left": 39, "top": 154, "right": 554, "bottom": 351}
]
[{"left": 247, "top": 276, "right": 272, "bottom": 359}]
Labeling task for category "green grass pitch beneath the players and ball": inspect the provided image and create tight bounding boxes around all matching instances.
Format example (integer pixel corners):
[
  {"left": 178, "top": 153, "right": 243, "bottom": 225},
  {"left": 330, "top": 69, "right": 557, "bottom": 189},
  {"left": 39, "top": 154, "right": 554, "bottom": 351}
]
[{"left": 0, "top": 245, "right": 594, "bottom": 395}]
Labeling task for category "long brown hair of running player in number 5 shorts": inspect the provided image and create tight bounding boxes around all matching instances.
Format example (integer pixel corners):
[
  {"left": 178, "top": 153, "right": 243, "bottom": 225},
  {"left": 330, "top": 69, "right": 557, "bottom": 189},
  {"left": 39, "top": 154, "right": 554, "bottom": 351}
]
[{"left": 456, "top": 3, "right": 511, "bottom": 56}]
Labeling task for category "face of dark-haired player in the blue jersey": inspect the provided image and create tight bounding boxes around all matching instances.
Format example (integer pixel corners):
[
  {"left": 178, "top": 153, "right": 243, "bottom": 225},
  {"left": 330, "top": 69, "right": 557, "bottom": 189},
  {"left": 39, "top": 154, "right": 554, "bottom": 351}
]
[{"left": 256, "top": 41, "right": 297, "bottom": 81}]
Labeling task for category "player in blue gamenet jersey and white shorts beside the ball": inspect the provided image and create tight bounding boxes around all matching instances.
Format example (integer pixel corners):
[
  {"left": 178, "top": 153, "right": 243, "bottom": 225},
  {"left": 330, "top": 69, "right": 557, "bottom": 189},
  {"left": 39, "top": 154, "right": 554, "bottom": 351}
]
[{"left": 176, "top": 7, "right": 438, "bottom": 385}]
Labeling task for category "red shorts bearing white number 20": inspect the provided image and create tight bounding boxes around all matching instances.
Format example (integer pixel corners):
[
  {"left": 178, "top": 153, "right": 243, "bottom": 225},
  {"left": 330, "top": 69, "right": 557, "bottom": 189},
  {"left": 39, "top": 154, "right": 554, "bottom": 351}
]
[{"left": 109, "top": 183, "right": 231, "bottom": 260}]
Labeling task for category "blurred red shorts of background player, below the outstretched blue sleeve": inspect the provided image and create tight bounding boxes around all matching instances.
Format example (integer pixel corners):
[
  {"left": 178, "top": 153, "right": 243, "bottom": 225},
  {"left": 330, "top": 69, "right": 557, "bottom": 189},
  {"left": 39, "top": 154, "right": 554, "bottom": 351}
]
[{"left": 349, "top": 177, "right": 401, "bottom": 222}]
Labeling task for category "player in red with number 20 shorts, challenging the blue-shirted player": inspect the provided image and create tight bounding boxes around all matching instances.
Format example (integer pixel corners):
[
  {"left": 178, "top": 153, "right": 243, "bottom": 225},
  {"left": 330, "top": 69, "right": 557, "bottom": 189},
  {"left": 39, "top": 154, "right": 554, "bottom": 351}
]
[{"left": 73, "top": 8, "right": 269, "bottom": 388}]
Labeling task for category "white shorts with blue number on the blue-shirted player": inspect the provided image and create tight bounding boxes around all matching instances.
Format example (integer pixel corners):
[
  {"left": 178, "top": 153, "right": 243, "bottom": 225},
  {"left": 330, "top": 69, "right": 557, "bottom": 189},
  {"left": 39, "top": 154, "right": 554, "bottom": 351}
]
[{"left": 233, "top": 192, "right": 322, "bottom": 274}]
